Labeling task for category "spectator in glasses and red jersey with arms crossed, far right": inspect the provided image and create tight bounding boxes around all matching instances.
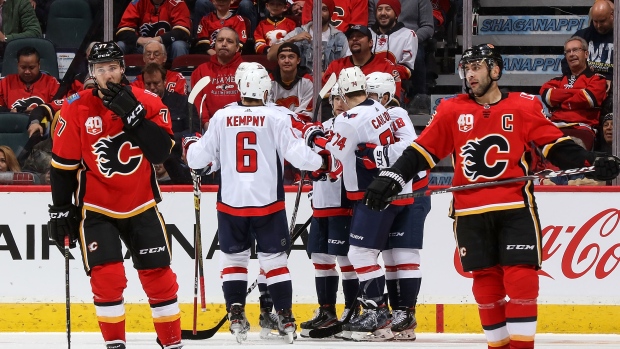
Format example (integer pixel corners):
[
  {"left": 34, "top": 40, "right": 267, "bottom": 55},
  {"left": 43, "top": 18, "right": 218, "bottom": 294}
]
[{"left": 540, "top": 36, "right": 607, "bottom": 150}]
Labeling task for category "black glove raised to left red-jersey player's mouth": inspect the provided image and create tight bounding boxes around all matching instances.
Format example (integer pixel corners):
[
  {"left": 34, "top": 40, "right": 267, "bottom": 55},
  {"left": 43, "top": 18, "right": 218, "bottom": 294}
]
[{"left": 100, "top": 81, "right": 146, "bottom": 129}]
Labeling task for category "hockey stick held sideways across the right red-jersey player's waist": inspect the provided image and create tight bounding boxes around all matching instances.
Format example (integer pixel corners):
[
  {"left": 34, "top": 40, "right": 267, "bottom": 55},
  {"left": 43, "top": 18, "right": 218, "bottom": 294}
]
[{"left": 387, "top": 166, "right": 594, "bottom": 202}]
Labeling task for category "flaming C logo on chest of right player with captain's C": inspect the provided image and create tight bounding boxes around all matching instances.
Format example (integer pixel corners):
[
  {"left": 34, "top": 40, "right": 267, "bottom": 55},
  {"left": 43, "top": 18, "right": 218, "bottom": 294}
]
[{"left": 460, "top": 134, "right": 510, "bottom": 181}]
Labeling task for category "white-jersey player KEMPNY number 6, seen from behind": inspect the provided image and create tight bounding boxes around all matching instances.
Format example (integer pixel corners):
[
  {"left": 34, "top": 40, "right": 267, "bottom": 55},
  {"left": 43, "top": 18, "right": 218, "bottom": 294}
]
[{"left": 183, "top": 69, "right": 337, "bottom": 343}]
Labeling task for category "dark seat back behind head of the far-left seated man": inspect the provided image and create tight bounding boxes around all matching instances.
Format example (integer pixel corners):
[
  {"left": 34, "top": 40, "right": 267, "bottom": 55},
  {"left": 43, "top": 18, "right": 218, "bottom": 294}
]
[{"left": 2, "top": 38, "right": 58, "bottom": 79}]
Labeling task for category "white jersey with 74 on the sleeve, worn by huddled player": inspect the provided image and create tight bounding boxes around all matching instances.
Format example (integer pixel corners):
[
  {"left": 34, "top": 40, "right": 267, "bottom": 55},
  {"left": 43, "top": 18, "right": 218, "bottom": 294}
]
[{"left": 327, "top": 99, "right": 413, "bottom": 204}]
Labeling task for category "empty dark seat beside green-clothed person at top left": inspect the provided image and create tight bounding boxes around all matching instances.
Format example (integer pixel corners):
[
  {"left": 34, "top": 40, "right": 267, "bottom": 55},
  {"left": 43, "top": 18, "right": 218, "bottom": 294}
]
[{"left": 45, "top": 0, "right": 93, "bottom": 52}]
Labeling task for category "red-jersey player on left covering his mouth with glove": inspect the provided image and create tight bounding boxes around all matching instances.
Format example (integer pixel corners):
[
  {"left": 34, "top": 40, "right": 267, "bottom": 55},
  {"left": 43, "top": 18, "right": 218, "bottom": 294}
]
[{"left": 48, "top": 42, "right": 182, "bottom": 349}]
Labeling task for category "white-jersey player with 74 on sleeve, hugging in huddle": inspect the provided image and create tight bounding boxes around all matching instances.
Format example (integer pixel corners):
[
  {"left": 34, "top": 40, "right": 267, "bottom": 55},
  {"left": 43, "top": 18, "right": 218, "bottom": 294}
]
[{"left": 304, "top": 67, "right": 413, "bottom": 340}]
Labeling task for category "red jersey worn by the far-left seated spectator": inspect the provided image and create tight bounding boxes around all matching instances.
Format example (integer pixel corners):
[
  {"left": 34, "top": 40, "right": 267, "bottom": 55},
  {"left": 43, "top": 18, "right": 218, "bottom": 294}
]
[{"left": 0, "top": 74, "right": 59, "bottom": 113}]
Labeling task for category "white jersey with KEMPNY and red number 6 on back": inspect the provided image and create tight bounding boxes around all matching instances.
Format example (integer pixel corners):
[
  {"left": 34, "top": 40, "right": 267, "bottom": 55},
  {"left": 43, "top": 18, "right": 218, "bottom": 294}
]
[{"left": 187, "top": 104, "right": 323, "bottom": 216}]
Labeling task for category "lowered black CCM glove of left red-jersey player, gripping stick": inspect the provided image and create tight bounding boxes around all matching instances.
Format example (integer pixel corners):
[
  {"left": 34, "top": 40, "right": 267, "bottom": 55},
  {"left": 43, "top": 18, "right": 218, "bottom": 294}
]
[{"left": 47, "top": 205, "right": 80, "bottom": 248}]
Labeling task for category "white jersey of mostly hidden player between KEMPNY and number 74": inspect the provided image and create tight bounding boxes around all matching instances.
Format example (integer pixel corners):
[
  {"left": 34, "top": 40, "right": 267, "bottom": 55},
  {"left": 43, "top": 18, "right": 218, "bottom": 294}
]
[{"left": 312, "top": 118, "right": 351, "bottom": 217}]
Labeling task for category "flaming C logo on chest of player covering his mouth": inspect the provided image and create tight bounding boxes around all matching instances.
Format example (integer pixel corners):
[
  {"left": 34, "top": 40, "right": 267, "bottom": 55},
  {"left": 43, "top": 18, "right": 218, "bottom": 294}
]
[{"left": 93, "top": 132, "right": 143, "bottom": 178}]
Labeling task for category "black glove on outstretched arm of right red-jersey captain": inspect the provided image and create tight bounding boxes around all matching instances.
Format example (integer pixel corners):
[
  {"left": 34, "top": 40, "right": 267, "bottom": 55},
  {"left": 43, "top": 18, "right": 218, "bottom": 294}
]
[{"left": 362, "top": 168, "right": 405, "bottom": 211}]
